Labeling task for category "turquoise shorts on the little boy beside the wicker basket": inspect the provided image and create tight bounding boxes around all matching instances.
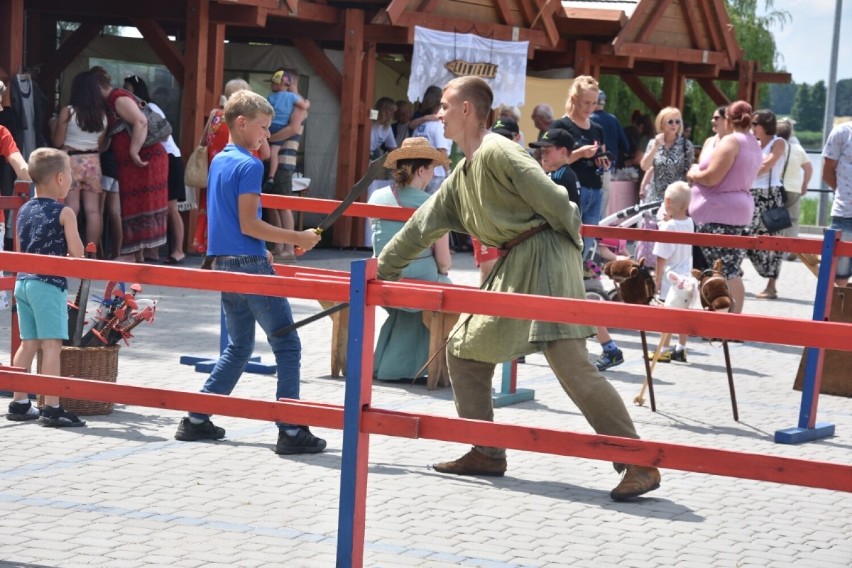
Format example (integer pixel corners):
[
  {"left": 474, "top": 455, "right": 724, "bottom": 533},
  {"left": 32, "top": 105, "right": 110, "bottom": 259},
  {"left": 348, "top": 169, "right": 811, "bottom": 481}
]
[{"left": 15, "top": 280, "right": 68, "bottom": 341}]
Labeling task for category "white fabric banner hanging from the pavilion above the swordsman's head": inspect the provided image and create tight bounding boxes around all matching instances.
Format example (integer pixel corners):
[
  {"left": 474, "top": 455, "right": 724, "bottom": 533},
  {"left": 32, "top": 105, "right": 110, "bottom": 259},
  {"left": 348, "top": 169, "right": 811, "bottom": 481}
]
[{"left": 408, "top": 26, "right": 529, "bottom": 108}]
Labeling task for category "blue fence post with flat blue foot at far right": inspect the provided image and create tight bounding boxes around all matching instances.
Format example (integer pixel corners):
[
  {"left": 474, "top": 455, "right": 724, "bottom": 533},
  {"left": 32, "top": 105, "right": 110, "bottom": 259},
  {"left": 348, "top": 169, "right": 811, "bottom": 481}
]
[{"left": 775, "top": 229, "right": 840, "bottom": 444}]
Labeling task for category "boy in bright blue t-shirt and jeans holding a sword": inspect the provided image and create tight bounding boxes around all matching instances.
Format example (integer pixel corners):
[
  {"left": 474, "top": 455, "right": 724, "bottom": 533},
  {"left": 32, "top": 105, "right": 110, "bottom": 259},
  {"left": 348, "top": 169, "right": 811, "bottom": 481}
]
[{"left": 175, "top": 91, "right": 325, "bottom": 454}]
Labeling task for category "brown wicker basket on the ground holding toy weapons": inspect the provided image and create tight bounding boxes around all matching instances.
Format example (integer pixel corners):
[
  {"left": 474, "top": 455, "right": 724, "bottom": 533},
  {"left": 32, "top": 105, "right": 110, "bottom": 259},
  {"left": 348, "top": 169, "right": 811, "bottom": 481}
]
[{"left": 36, "top": 345, "right": 119, "bottom": 416}]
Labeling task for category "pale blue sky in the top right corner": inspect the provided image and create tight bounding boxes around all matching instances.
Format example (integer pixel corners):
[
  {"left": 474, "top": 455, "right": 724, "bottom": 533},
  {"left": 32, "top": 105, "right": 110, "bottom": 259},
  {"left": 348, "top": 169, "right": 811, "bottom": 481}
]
[{"left": 758, "top": 0, "right": 852, "bottom": 85}]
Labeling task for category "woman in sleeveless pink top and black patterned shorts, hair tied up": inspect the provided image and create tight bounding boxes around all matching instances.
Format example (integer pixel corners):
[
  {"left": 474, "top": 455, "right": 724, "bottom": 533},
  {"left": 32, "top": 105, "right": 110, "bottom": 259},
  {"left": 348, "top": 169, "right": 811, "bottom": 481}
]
[{"left": 686, "top": 101, "right": 763, "bottom": 313}]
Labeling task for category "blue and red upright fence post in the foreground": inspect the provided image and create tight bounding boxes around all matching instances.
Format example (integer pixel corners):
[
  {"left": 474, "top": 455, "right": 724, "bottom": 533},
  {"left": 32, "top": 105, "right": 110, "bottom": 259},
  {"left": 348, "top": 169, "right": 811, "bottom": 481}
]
[{"left": 337, "top": 259, "right": 376, "bottom": 568}]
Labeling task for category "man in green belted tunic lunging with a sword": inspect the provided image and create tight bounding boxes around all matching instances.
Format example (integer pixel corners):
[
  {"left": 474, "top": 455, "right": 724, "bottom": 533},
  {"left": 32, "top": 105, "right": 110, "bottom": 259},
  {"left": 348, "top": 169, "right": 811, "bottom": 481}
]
[{"left": 378, "top": 77, "right": 660, "bottom": 501}]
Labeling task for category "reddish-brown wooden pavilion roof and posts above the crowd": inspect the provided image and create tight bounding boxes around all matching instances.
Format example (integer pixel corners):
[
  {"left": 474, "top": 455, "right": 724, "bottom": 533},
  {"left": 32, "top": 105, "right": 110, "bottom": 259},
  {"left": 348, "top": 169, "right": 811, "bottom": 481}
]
[{"left": 0, "top": 0, "right": 790, "bottom": 246}]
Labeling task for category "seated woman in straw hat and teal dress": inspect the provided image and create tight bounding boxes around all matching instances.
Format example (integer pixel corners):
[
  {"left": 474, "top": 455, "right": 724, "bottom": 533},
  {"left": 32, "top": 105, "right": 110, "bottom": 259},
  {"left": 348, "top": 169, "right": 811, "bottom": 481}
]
[{"left": 369, "top": 137, "right": 451, "bottom": 381}]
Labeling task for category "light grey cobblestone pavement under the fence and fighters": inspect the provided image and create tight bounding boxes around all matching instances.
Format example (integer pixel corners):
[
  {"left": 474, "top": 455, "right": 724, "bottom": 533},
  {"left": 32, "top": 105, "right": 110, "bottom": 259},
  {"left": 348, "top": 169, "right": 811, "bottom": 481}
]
[{"left": 0, "top": 250, "right": 852, "bottom": 568}]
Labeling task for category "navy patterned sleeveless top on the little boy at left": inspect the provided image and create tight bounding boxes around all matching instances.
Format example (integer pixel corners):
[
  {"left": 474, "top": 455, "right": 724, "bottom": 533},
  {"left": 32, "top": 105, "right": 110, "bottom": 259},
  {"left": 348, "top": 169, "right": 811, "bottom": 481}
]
[{"left": 17, "top": 197, "right": 68, "bottom": 291}]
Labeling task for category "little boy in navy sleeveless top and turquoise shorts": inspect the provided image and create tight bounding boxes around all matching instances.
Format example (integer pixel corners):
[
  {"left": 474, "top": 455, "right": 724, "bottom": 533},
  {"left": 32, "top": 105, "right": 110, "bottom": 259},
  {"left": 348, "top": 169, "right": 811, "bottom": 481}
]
[{"left": 6, "top": 148, "right": 86, "bottom": 428}]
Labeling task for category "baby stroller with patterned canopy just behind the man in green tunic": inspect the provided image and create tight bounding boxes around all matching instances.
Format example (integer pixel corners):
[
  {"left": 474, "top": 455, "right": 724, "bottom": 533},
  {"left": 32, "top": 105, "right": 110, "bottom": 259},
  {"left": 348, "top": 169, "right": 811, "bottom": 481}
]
[{"left": 583, "top": 201, "right": 663, "bottom": 301}]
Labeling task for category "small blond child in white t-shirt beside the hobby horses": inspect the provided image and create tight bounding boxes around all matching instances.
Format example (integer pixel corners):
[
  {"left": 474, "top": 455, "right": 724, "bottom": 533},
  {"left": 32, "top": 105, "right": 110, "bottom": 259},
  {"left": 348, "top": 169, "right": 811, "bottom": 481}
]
[{"left": 654, "top": 181, "right": 695, "bottom": 363}]
